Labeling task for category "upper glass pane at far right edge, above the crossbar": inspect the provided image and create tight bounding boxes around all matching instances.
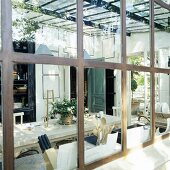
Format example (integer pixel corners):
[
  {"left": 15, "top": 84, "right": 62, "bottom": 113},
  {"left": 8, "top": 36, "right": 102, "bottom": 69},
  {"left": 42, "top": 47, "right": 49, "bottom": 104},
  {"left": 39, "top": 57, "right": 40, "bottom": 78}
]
[{"left": 154, "top": 4, "right": 170, "bottom": 68}]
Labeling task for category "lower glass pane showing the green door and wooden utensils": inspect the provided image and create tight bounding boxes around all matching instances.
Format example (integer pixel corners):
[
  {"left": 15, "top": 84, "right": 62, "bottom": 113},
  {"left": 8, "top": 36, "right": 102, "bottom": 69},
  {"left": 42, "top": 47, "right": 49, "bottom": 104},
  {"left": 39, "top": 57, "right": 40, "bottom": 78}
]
[{"left": 84, "top": 68, "right": 122, "bottom": 164}]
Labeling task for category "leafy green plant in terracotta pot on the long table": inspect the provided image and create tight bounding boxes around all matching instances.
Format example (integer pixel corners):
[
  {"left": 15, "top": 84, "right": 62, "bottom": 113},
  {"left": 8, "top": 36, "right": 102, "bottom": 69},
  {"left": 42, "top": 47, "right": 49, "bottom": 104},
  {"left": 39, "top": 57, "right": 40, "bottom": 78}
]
[{"left": 50, "top": 98, "right": 77, "bottom": 125}]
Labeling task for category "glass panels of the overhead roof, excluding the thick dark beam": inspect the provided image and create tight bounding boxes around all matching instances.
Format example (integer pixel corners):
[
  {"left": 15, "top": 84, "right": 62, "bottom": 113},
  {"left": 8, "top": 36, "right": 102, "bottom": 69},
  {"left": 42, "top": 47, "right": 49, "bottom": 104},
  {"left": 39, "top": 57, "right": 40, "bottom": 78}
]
[{"left": 11, "top": 0, "right": 170, "bottom": 35}]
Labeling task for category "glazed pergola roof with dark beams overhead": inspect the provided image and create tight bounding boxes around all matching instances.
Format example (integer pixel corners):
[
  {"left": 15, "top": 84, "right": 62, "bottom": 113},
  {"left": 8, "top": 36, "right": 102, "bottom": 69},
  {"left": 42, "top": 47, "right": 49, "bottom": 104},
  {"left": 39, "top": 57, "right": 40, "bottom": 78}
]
[{"left": 12, "top": 0, "right": 170, "bottom": 35}]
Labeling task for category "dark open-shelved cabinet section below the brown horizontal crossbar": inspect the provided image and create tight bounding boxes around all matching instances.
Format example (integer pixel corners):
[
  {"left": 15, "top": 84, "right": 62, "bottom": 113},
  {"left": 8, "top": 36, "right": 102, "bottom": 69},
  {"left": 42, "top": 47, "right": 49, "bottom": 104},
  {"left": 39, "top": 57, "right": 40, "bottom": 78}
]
[{"left": 13, "top": 64, "right": 36, "bottom": 122}]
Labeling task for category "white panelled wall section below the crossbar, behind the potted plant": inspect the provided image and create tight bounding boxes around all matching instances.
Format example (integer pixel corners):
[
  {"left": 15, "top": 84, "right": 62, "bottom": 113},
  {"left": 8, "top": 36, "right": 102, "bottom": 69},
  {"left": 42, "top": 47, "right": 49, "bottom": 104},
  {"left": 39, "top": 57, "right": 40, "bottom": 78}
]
[{"left": 36, "top": 64, "right": 70, "bottom": 121}]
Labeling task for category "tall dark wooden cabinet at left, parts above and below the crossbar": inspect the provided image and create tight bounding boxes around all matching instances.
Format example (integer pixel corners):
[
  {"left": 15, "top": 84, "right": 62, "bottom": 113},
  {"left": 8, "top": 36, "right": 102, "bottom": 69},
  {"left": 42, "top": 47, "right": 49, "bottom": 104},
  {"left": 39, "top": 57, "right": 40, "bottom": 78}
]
[{"left": 13, "top": 42, "right": 36, "bottom": 122}]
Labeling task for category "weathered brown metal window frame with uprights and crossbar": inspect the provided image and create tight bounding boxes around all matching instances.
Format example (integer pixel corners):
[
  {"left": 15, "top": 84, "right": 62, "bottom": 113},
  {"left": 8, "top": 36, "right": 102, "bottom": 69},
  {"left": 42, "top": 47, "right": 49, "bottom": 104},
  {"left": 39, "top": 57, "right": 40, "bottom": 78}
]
[{"left": 0, "top": 0, "right": 170, "bottom": 170}]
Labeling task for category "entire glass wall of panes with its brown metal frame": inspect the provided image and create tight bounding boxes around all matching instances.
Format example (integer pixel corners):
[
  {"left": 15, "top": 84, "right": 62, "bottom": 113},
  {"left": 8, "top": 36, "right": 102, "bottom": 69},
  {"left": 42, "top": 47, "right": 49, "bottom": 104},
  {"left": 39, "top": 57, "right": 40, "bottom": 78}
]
[{"left": 0, "top": 0, "right": 170, "bottom": 170}]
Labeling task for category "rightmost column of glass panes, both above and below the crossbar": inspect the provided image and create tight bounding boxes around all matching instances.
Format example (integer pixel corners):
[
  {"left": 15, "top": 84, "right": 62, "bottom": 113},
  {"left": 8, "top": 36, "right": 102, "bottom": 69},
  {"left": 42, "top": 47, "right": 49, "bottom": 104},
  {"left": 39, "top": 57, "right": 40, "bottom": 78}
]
[{"left": 154, "top": 1, "right": 170, "bottom": 136}]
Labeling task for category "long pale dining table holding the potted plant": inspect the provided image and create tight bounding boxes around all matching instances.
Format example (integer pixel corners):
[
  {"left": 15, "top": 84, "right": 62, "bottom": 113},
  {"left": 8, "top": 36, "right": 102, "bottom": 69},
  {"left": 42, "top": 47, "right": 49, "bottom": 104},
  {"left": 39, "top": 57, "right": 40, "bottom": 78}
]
[{"left": 0, "top": 114, "right": 121, "bottom": 155}]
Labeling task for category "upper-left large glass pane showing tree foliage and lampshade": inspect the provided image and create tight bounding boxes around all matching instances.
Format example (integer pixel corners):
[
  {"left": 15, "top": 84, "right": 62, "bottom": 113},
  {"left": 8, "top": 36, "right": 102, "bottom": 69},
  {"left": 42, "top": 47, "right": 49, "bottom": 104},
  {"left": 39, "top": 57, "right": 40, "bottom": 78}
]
[{"left": 12, "top": 0, "right": 77, "bottom": 58}]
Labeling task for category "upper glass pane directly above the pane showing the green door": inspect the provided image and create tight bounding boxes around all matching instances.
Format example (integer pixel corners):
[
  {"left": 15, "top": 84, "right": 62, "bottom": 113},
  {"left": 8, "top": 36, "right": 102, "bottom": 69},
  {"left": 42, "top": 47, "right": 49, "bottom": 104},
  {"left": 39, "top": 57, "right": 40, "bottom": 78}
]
[{"left": 83, "top": 1, "right": 121, "bottom": 63}]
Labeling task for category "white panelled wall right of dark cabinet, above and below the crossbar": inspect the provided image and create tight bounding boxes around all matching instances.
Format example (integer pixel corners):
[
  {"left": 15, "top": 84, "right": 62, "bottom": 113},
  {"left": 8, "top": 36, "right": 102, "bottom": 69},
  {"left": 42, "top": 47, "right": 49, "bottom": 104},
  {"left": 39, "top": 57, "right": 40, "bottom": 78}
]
[{"left": 36, "top": 27, "right": 73, "bottom": 121}]
